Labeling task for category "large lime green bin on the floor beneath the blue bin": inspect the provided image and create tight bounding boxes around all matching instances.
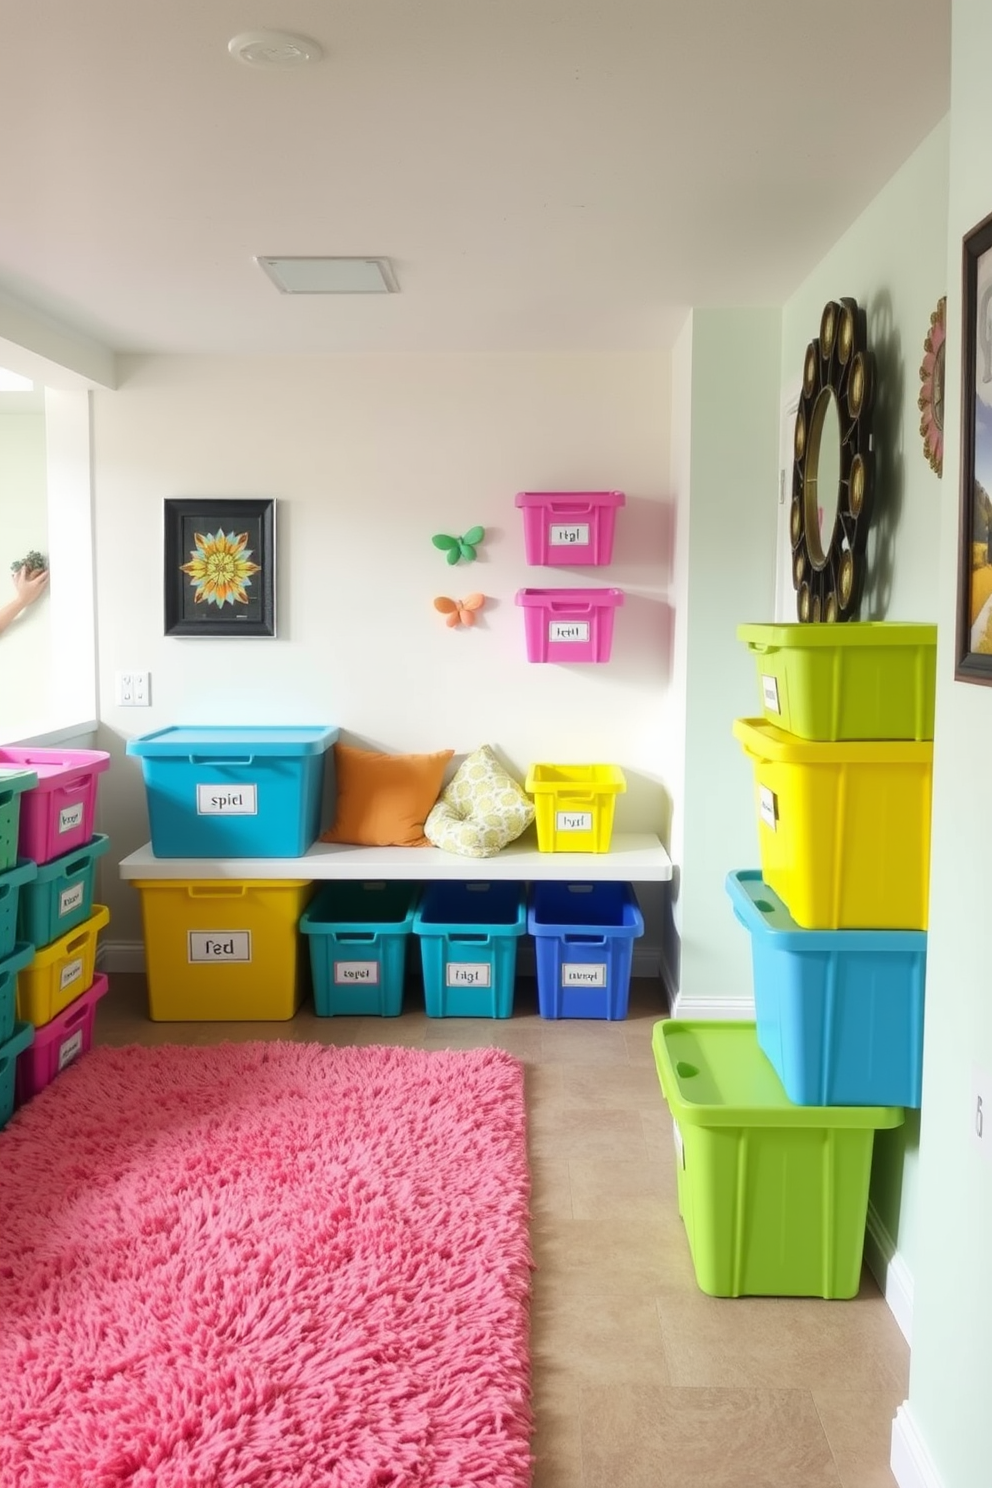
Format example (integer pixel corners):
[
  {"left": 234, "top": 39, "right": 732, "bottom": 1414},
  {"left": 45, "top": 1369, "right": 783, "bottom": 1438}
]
[{"left": 653, "top": 1019, "right": 903, "bottom": 1298}]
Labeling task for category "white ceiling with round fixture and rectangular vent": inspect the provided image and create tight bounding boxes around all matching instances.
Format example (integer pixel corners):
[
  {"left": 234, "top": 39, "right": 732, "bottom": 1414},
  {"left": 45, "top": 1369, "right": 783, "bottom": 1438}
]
[{"left": 0, "top": 0, "right": 950, "bottom": 353}]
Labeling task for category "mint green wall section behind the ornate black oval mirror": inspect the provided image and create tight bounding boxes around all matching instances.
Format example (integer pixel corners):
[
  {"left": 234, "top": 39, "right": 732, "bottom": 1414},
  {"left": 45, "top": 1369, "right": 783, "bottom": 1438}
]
[{"left": 782, "top": 119, "right": 953, "bottom": 1315}]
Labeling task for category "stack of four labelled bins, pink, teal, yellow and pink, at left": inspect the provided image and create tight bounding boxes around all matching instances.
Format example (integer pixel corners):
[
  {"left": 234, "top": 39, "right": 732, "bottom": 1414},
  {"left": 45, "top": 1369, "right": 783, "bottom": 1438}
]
[{"left": 0, "top": 748, "right": 110, "bottom": 1104}]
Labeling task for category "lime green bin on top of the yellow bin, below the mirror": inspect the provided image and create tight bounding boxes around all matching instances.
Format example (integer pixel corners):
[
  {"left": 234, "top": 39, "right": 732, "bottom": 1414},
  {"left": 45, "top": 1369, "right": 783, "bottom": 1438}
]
[{"left": 738, "top": 620, "right": 937, "bottom": 743}]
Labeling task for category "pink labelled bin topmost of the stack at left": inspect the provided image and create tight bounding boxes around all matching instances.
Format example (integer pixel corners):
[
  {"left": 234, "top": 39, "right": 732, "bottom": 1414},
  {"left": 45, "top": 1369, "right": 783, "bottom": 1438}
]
[{"left": 0, "top": 747, "right": 110, "bottom": 863}]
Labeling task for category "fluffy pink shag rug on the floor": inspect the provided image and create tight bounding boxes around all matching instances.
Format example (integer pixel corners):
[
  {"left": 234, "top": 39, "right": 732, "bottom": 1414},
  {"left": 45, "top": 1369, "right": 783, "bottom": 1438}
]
[{"left": 0, "top": 1042, "right": 531, "bottom": 1488}]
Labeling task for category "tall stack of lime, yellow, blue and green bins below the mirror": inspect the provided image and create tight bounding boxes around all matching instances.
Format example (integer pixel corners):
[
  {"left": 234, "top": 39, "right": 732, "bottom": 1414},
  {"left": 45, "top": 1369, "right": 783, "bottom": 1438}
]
[{"left": 654, "top": 622, "right": 937, "bottom": 1298}]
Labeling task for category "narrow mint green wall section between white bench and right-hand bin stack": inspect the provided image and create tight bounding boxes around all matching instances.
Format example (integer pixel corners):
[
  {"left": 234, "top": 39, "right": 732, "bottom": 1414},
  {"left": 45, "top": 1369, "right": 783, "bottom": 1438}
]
[{"left": 672, "top": 310, "right": 781, "bottom": 1016}]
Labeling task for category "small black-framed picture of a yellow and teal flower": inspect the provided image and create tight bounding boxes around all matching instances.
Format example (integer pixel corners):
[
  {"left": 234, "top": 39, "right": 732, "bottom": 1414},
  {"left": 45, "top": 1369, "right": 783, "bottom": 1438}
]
[{"left": 165, "top": 497, "right": 275, "bottom": 640}]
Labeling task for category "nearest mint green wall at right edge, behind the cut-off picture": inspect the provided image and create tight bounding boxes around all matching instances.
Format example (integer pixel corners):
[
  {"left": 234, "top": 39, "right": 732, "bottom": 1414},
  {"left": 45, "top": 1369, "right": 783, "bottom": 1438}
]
[{"left": 909, "top": 0, "right": 992, "bottom": 1488}]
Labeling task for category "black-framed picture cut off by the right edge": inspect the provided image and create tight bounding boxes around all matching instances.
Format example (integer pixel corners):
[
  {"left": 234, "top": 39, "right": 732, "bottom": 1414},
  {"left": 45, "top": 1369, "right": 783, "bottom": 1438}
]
[{"left": 955, "top": 214, "right": 992, "bottom": 686}]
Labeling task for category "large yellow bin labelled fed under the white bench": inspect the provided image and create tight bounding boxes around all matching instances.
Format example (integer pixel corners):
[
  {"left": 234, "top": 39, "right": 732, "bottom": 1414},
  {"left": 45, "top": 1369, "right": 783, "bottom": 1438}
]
[{"left": 134, "top": 878, "right": 314, "bottom": 1022}]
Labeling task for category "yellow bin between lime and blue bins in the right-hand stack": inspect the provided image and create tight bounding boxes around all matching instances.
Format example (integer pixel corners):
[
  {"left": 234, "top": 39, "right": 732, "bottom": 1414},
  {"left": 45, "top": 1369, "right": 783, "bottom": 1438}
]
[{"left": 733, "top": 719, "right": 934, "bottom": 930}]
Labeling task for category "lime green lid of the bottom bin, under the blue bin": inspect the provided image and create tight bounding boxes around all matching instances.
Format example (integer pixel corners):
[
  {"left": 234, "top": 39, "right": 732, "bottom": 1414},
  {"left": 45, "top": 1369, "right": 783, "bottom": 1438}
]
[{"left": 651, "top": 1018, "right": 904, "bottom": 1128}]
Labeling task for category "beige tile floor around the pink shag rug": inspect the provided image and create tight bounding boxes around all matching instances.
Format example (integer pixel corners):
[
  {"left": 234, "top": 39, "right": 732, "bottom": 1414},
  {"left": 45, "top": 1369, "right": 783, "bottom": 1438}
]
[{"left": 97, "top": 975, "right": 909, "bottom": 1488}]
